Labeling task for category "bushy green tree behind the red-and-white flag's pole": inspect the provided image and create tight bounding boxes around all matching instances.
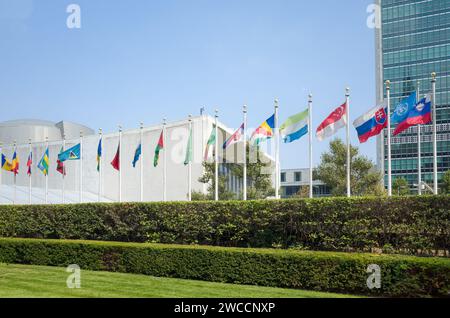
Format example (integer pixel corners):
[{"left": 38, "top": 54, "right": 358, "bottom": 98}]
[{"left": 314, "top": 139, "right": 386, "bottom": 196}]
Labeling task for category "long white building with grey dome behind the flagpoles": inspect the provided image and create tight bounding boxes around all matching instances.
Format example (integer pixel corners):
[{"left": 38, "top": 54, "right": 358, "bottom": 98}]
[{"left": 0, "top": 116, "right": 271, "bottom": 204}]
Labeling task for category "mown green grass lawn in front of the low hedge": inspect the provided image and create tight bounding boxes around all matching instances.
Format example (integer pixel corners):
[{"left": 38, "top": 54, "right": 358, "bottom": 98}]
[{"left": 0, "top": 264, "right": 358, "bottom": 298}]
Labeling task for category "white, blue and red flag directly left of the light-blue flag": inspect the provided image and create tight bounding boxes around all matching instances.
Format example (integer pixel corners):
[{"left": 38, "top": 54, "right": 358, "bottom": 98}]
[{"left": 353, "top": 105, "right": 387, "bottom": 143}]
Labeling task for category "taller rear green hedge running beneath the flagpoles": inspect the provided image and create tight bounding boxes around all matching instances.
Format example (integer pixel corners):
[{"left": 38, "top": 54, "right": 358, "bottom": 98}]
[{"left": 0, "top": 196, "right": 450, "bottom": 255}]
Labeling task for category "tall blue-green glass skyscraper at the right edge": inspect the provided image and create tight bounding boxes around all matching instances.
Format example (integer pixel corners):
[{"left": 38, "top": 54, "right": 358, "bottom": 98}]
[{"left": 376, "top": 0, "right": 450, "bottom": 190}]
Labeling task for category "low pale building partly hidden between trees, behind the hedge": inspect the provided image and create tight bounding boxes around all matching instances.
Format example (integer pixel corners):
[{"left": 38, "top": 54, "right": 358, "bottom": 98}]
[{"left": 281, "top": 168, "right": 331, "bottom": 198}]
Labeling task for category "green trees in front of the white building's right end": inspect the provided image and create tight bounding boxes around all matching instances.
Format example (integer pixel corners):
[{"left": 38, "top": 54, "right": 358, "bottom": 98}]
[{"left": 197, "top": 145, "right": 275, "bottom": 200}]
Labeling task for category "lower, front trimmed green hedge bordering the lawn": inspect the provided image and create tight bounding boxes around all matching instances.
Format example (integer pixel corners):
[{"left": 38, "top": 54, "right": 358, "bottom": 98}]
[{"left": 0, "top": 239, "right": 450, "bottom": 297}]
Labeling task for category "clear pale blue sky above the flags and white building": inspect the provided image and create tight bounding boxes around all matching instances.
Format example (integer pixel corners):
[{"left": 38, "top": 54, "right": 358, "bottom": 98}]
[{"left": 0, "top": 0, "right": 376, "bottom": 168}]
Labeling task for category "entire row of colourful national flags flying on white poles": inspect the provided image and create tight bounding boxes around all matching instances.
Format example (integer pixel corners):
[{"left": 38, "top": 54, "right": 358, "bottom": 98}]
[{"left": 1, "top": 92, "right": 431, "bottom": 175}]
